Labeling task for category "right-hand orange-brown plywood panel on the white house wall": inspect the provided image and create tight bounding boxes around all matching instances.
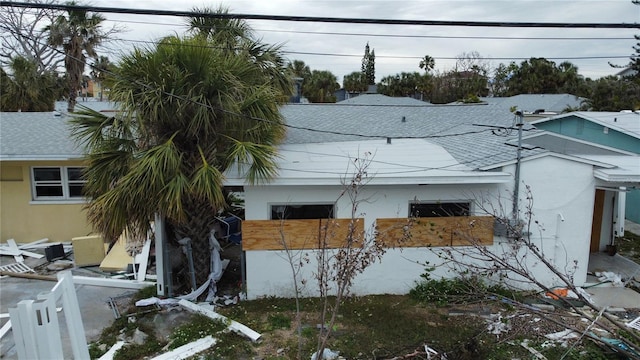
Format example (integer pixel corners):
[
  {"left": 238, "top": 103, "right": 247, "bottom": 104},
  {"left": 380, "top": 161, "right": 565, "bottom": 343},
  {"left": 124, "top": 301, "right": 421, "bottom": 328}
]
[{"left": 376, "top": 216, "right": 494, "bottom": 247}]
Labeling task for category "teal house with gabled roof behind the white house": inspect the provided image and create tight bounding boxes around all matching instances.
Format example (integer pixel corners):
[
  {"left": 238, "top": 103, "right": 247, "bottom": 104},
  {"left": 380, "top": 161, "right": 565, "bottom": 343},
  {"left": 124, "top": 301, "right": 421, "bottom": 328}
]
[{"left": 531, "top": 111, "right": 640, "bottom": 225}]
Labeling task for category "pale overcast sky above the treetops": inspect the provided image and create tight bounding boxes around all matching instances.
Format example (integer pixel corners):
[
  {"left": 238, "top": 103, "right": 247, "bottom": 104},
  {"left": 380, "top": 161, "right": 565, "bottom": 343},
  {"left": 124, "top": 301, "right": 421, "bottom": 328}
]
[{"left": 88, "top": 0, "right": 640, "bottom": 82}]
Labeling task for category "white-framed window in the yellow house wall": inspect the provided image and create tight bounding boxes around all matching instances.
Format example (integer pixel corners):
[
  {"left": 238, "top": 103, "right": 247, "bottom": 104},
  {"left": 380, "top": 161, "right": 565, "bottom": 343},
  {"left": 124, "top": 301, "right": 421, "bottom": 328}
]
[{"left": 31, "top": 166, "right": 86, "bottom": 200}]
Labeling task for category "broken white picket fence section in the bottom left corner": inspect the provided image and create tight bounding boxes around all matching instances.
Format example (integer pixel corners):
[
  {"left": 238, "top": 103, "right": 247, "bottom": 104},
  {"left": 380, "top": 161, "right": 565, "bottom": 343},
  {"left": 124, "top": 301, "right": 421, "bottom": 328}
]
[{"left": 9, "top": 271, "right": 89, "bottom": 360}]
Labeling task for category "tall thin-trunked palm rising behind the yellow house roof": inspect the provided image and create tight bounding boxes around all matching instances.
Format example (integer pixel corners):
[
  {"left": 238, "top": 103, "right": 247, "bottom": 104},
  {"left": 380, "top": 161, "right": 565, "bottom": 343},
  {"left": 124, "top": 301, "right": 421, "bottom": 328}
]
[{"left": 46, "top": 2, "right": 107, "bottom": 112}]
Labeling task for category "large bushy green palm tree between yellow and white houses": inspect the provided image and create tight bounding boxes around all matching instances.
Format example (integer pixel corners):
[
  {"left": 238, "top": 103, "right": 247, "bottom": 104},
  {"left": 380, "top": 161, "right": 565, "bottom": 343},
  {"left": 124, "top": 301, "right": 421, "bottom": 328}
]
[{"left": 72, "top": 35, "right": 289, "bottom": 290}]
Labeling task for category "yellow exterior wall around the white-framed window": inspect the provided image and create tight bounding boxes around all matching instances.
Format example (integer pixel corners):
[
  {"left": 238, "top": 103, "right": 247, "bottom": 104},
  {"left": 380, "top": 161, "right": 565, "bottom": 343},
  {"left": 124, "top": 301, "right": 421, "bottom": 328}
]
[{"left": 0, "top": 161, "right": 91, "bottom": 242}]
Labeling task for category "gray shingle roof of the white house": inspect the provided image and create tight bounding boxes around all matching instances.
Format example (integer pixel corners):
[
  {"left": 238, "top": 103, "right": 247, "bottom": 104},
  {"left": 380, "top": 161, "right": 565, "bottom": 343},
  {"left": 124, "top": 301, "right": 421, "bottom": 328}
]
[{"left": 281, "top": 104, "right": 545, "bottom": 168}]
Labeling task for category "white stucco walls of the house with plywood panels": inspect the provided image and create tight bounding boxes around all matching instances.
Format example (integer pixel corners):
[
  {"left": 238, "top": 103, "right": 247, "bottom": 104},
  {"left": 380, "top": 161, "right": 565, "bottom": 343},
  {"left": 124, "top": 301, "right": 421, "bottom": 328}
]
[{"left": 240, "top": 157, "right": 595, "bottom": 299}]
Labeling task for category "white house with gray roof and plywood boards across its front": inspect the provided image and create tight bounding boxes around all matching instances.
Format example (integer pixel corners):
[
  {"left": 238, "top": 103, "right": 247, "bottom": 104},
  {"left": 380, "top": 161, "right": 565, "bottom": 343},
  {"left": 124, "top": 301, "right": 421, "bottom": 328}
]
[{"left": 227, "top": 95, "right": 640, "bottom": 298}]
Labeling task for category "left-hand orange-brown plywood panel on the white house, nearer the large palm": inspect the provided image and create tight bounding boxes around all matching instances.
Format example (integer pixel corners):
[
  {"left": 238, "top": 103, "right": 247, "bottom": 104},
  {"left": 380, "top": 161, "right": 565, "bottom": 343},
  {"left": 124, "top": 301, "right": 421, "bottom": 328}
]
[{"left": 242, "top": 219, "right": 364, "bottom": 251}]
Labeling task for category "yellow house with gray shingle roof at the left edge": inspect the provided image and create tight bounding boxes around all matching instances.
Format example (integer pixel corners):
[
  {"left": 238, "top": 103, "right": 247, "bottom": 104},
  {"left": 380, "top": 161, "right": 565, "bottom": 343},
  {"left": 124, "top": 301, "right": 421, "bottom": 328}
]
[{"left": 0, "top": 112, "right": 91, "bottom": 242}]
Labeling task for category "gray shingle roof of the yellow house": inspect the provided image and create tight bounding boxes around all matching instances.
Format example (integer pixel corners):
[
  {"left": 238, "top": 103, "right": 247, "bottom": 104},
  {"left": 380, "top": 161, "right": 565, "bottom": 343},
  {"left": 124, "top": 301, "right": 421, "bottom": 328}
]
[{"left": 0, "top": 112, "right": 82, "bottom": 160}]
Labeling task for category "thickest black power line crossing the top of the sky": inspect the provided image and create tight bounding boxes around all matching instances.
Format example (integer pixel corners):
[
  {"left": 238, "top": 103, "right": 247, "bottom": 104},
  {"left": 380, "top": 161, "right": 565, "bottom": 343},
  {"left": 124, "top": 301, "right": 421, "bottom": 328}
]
[{"left": 5, "top": 1, "right": 640, "bottom": 29}]
